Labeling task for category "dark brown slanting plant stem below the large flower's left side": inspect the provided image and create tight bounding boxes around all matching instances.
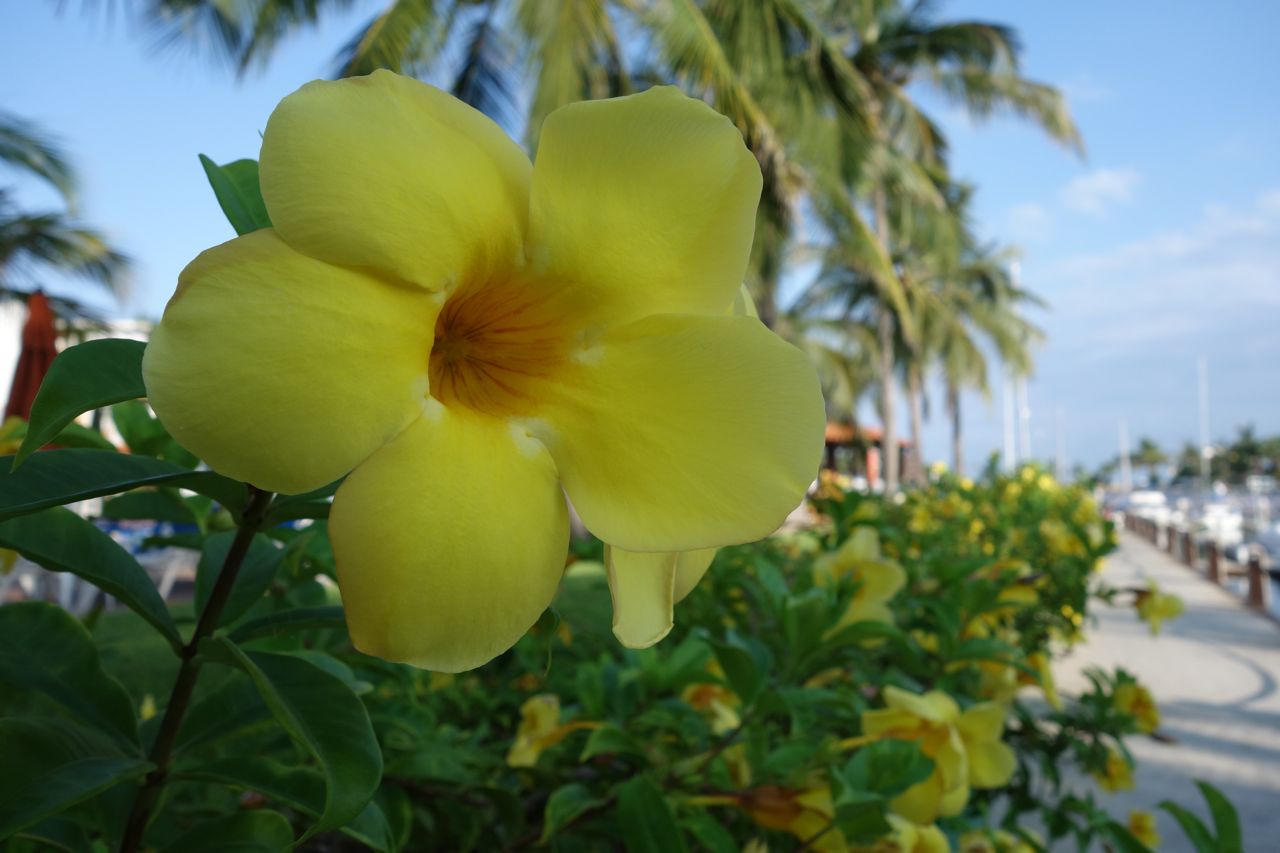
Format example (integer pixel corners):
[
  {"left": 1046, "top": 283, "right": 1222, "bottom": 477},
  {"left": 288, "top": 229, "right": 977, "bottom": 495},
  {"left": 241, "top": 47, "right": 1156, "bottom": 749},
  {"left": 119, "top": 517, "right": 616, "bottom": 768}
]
[{"left": 120, "top": 485, "right": 274, "bottom": 853}]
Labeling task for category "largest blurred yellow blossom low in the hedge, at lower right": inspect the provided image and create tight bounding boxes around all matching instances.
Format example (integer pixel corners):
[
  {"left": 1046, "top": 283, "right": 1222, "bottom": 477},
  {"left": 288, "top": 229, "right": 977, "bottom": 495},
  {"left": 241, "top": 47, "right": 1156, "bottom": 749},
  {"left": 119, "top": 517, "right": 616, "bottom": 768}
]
[{"left": 861, "top": 686, "right": 1016, "bottom": 824}]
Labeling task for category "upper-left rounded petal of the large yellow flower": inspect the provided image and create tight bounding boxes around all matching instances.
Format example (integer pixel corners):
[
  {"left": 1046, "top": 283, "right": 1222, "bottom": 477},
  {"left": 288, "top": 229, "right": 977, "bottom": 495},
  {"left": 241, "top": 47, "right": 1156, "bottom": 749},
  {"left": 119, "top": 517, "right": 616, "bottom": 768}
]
[{"left": 260, "top": 70, "right": 531, "bottom": 291}]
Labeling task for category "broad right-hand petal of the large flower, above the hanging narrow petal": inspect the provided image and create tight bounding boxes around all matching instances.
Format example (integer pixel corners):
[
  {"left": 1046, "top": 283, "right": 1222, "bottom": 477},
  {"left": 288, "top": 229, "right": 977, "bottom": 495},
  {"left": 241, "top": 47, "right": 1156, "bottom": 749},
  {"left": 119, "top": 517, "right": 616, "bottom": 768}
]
[{"left": 530, "top": 315, "right": 824, "bottom": 551}]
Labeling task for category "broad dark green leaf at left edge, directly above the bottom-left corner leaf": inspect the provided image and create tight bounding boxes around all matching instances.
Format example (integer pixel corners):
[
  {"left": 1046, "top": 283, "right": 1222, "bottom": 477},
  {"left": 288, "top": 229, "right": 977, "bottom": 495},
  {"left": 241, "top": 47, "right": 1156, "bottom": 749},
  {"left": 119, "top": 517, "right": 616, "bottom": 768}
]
[{"left": 0, "top": 601, "right": 138, "bottom": 742}]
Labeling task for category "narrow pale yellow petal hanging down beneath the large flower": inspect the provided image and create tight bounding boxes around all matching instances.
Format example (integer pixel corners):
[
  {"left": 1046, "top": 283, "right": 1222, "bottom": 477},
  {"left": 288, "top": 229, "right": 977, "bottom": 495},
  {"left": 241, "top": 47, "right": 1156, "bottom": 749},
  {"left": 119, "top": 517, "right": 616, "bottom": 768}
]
[{"left": 604, "top": 546, "right": 680, "bottom": 648}]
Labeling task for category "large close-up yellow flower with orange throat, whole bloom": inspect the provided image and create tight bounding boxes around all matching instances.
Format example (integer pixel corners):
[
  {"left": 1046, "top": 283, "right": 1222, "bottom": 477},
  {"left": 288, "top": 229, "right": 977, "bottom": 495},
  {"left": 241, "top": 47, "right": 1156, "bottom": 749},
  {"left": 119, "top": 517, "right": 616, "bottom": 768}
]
[{"left": 143, "top": 70, "right": 826, "bottom": 671}]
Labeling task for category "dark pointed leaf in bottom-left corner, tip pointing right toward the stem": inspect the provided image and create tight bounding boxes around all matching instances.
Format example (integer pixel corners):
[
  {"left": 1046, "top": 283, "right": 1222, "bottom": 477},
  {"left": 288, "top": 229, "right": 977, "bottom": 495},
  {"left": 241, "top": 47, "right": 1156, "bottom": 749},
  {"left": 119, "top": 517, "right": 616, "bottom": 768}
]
[{"left": 0, "top": 712, "right": 151, "bottom": 839}]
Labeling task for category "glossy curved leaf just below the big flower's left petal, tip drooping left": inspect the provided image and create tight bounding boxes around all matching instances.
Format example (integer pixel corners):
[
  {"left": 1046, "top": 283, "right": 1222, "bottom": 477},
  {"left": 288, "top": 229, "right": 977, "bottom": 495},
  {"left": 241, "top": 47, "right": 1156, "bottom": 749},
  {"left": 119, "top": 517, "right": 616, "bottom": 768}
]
[{"left": 13, "top": 338, "right": 147, "bottom": 467}]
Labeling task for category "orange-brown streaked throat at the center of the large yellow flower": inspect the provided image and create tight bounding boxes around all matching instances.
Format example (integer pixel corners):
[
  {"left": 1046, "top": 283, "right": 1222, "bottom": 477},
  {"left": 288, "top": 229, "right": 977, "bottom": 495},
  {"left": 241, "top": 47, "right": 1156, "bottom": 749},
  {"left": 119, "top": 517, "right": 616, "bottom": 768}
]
[{"left": 428, "top": 282, "right": 568, "bottom": 415}]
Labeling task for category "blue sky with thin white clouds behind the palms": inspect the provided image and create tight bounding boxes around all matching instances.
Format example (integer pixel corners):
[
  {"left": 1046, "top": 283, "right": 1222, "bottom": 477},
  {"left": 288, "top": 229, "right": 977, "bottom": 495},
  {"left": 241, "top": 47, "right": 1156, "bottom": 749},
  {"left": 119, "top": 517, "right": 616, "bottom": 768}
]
[{"left": 0, "top": 0, "right": 1280, "bottom": 466}]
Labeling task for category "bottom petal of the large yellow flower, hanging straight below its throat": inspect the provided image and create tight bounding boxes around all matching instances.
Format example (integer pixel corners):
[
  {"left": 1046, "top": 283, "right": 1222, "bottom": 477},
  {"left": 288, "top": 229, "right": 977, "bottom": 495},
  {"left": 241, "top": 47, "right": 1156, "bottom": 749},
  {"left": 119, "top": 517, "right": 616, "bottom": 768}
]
[{"left": 329, "top": 403, "right": 568, "bottom": 672}]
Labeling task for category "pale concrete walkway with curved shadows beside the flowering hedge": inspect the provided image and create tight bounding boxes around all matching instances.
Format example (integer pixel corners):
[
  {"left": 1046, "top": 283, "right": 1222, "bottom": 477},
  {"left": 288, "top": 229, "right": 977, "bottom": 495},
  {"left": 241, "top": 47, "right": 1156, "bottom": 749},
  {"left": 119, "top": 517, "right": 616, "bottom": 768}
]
[{"left": 1055, "top": 533, "right": 1280, "bottom": 853}]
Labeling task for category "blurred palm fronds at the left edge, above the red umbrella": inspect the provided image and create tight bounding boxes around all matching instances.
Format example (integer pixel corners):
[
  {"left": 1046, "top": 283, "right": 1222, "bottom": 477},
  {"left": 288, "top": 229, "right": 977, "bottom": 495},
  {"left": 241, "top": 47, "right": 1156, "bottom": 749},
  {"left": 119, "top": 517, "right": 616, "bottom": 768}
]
[{"left": 0, "top": 114, "right": 128, "bottom": 298}]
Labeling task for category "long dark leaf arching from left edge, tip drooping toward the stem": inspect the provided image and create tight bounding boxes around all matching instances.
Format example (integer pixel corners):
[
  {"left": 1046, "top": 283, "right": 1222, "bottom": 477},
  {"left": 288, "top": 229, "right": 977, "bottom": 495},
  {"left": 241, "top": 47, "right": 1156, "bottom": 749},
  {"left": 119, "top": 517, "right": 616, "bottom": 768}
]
[{"left": 0, "top": 507, "right": 182, "bottom": 649}]
